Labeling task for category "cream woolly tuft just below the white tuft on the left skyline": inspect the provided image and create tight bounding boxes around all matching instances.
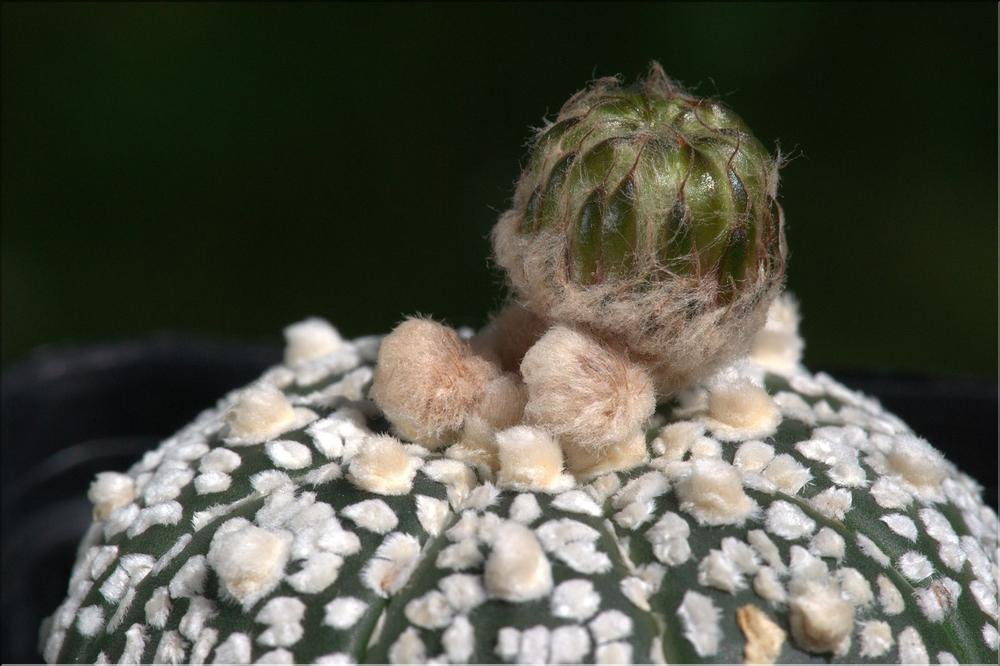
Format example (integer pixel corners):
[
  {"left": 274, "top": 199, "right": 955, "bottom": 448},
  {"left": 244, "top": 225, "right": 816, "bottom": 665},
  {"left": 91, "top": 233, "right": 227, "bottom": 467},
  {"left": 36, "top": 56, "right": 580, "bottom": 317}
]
[{"left": 226, "top": 384, "right": 316, "bottom": 444}]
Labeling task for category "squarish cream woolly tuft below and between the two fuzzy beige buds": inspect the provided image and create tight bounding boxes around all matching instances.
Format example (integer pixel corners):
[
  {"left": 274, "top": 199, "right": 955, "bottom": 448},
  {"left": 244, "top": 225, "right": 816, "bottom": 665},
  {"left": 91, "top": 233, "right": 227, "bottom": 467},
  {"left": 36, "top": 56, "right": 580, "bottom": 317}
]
[{"left": 496, "top": 426, "right": 563, "bottom": 490}]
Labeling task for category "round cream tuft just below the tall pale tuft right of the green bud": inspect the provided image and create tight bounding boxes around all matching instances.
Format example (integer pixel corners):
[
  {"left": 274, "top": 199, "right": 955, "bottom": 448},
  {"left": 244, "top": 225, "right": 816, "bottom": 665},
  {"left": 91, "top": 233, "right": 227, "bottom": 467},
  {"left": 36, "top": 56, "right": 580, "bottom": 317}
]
[{"left": 705, "top": 382, "right": 781, "bottom": 442}]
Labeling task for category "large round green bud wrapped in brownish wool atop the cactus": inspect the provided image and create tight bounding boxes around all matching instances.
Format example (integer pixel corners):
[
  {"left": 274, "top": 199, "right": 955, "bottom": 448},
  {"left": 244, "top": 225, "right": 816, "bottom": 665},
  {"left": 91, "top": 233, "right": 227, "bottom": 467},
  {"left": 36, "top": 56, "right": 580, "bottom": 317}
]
[{"left": 493, "top": 63, "right": 785, "bottom": 393}]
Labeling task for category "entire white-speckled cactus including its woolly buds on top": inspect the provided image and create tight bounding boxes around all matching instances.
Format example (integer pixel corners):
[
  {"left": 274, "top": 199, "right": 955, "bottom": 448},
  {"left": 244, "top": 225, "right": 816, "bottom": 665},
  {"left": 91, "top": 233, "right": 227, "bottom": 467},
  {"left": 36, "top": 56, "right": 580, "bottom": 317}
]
[{"left": 42, "top": 64, "right": 1000, "bottom": 663}]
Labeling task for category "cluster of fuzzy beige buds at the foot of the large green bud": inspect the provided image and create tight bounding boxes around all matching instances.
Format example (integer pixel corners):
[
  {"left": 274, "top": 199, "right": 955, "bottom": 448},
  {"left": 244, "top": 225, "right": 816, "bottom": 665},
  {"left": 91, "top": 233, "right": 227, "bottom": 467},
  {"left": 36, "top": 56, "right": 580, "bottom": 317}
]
[{"left": 371, "top": 305, "right": 656, "bottom": 482}]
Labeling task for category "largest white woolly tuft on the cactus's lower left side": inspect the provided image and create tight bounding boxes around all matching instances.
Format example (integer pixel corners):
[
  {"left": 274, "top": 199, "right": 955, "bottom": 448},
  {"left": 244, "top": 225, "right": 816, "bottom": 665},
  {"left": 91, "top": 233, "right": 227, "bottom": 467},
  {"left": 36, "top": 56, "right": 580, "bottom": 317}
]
[{"left": 208, "top": 521, "right": 292, "bottom": 609}]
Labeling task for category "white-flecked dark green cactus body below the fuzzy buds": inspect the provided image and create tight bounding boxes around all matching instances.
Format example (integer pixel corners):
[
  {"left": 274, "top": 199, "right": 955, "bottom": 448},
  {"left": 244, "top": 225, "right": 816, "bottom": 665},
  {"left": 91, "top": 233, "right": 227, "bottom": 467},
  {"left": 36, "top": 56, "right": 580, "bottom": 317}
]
[{"left": 43, "top": 320, "right": 998, "bottom": 663}]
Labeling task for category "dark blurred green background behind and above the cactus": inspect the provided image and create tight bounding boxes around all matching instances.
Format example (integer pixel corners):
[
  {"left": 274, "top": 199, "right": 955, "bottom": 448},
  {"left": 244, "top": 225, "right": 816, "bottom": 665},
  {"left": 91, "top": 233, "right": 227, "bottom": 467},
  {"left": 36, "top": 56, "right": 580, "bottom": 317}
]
[{"left": 0, "top": 3, "right": 997, "bottom": 376}]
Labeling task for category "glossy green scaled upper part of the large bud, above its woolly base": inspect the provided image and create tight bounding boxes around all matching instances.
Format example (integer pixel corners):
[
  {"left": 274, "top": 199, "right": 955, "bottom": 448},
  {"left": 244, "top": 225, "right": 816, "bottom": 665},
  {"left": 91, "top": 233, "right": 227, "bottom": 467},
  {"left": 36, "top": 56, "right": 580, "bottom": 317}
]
[{"left": 521, "top": 82, "right": 780, "bottom": 302}]
